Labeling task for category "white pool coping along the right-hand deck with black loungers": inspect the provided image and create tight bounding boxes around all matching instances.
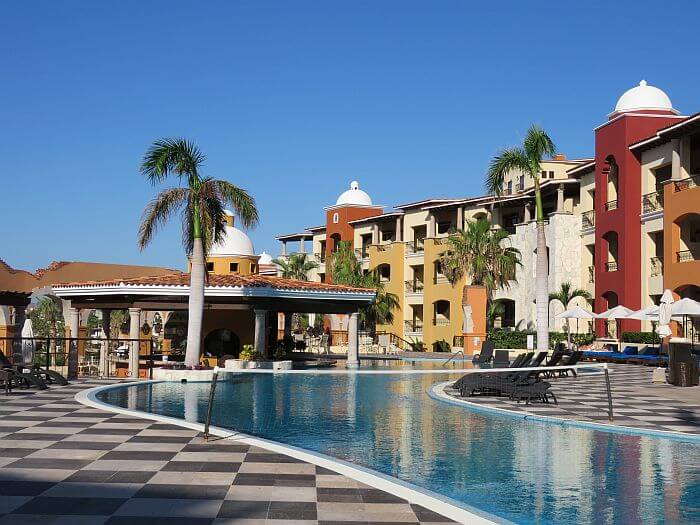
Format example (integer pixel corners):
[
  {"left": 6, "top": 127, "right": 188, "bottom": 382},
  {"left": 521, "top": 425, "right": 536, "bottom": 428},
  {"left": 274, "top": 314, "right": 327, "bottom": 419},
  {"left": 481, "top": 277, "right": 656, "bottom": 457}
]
[{"left": 427, "top": 381, "right": 700, "bottom": 443}]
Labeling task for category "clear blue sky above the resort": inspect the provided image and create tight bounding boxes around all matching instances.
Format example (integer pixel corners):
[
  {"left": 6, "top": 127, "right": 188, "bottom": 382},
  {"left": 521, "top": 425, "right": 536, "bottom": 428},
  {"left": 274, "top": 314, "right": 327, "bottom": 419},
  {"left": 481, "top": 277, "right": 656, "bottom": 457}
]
[{"left": 0, "top": 0, "right": 700, "bottom": 270}]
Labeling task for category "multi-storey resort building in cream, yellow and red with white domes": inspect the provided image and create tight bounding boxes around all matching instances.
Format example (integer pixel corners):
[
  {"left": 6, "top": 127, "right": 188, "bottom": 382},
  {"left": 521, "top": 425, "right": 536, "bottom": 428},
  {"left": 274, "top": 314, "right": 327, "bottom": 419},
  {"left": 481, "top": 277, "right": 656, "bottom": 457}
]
[{"left": 277, "top": 81, "right": 700, "bottom": 349}]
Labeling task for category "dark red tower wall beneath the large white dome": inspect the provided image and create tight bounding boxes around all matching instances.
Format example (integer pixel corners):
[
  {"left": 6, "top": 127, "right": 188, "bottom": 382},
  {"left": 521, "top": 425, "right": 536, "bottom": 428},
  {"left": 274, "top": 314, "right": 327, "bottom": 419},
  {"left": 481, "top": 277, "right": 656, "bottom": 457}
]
[{"left": 595, "top": 114, "right": 678, "bottom": 336}]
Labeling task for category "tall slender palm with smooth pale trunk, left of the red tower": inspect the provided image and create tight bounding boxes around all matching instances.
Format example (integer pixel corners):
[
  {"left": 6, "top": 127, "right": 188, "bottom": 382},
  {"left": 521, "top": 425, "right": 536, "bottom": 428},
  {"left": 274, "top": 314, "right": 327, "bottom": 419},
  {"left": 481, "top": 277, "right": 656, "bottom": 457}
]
[{"left": 486, "top": 125, "right": 556, "bottom": 352}]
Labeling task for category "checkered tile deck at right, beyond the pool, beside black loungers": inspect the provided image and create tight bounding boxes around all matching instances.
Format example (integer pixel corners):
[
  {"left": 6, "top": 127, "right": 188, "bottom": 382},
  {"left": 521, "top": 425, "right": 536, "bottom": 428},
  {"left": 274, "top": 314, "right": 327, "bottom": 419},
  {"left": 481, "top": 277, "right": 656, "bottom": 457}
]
[{"left": 445, "top": 364, "right": 700, "bottom": 434}]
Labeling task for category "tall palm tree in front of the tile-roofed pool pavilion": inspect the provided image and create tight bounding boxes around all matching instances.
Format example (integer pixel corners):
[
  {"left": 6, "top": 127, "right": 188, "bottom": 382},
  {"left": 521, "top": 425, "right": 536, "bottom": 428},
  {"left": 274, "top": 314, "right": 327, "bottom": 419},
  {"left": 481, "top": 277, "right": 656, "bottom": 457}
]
[{"left": 138, "top": 138, "right": 258, "bottom": 367}]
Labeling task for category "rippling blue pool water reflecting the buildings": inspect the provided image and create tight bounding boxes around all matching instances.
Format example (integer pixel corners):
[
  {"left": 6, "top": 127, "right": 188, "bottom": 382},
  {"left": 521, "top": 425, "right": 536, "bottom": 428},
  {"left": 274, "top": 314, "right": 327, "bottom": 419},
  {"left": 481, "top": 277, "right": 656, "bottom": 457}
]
[{"left": 97, "top": 373, "right": 700, "bottom": 524}]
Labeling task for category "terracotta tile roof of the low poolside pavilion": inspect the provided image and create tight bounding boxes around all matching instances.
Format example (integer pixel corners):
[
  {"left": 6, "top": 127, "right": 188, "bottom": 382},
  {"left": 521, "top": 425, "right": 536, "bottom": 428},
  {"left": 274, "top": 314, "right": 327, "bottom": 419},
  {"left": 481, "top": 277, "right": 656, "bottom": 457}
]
[{"left": 54, "top": 272, "right": 374, "bottom": 293}]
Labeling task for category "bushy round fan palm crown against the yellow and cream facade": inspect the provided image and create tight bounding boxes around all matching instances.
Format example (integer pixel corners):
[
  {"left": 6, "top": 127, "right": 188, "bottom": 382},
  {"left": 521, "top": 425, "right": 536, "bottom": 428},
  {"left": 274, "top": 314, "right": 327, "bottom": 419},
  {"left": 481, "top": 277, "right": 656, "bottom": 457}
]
[{"left": 440, "top": 219, "right": 521, "bottom": 296}]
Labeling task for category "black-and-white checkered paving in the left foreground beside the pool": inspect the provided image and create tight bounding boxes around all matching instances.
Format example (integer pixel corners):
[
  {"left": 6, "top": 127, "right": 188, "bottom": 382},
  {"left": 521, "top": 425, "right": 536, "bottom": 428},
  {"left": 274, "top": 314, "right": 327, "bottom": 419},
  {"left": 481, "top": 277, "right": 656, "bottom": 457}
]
[{"left": 0, "top": 381, "right": 453, "bottom": 525}]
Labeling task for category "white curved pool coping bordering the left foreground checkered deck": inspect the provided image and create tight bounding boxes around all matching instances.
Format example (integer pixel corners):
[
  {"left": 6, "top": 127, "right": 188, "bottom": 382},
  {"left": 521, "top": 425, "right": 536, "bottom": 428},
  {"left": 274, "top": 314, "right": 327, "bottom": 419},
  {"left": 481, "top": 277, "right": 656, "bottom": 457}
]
[{"left": 75, "top": 378, "right": 511, "bottom": 525}]
